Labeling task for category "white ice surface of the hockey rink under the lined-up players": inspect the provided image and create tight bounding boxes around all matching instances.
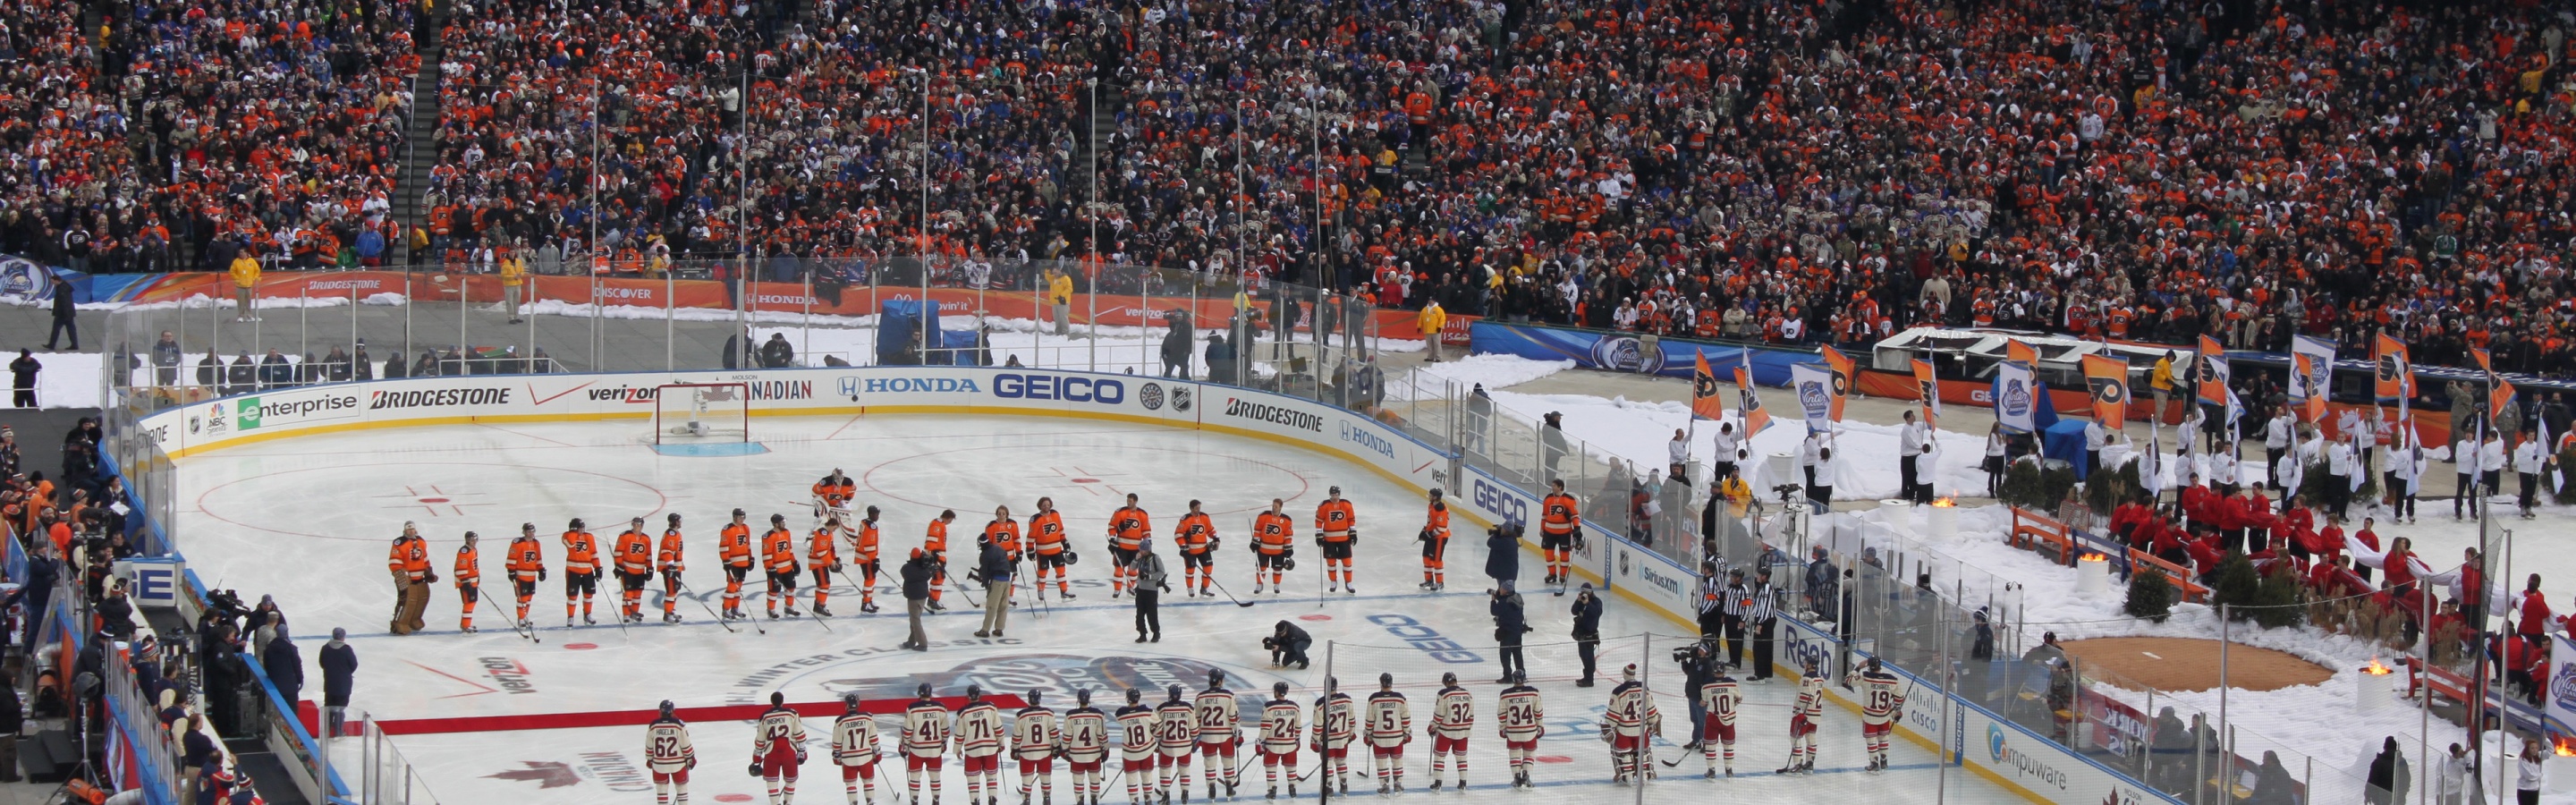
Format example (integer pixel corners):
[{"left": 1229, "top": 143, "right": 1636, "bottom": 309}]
[{"left": 178, "top": 415, "right": 2022, "bottom": 802}]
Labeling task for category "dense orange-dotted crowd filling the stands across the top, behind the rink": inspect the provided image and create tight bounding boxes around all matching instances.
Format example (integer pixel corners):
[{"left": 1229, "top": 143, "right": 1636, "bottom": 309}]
[{"left": 0, "top": 0, "right": 2576, "bottom": 374}]
